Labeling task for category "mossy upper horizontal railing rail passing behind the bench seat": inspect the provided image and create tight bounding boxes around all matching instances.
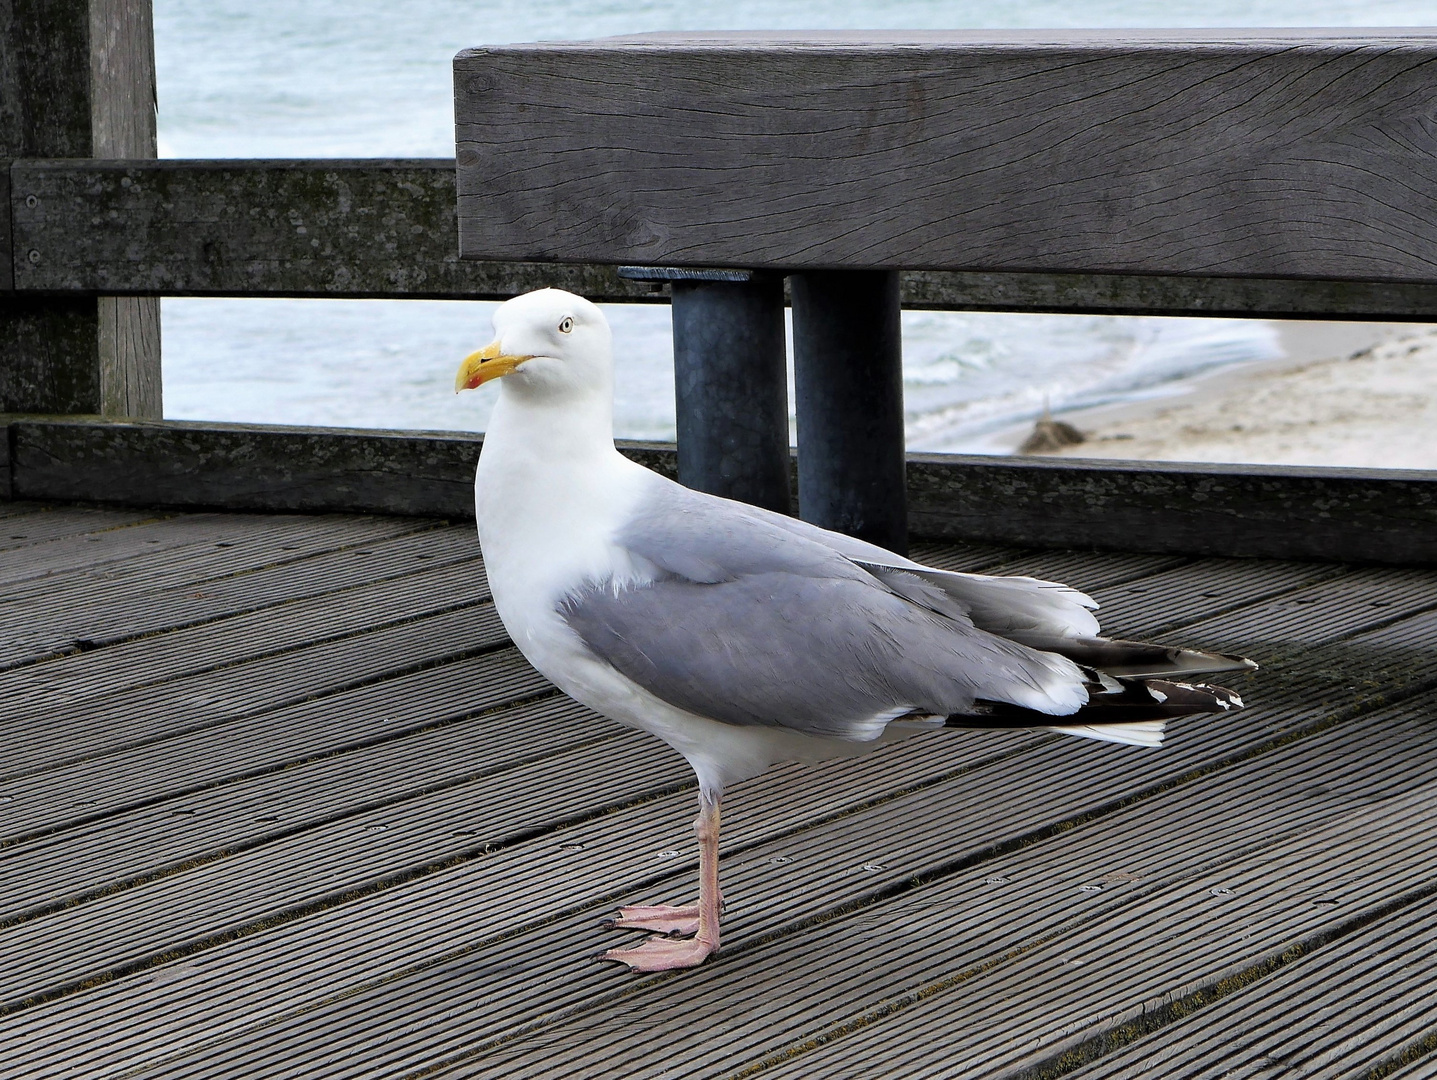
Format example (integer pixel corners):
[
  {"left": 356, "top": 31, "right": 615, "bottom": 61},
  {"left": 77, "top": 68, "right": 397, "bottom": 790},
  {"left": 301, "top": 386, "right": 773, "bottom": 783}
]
[{"left": 8, "top": 158, "right": 1437, "bottom": 320}]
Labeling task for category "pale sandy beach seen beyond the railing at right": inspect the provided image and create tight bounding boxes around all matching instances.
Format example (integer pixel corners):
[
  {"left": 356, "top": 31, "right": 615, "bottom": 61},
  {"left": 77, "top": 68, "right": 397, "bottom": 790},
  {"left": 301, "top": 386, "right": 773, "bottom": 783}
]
[{"left": 1015, "top": 322, "right": 1437, "bottom": 470}]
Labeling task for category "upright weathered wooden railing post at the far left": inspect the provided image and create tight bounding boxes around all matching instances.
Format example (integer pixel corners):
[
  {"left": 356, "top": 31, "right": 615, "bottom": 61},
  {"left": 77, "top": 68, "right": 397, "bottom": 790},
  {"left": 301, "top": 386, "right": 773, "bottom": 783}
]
[{"left": 0, "top": 0, "right": 162, "bottom": 418}]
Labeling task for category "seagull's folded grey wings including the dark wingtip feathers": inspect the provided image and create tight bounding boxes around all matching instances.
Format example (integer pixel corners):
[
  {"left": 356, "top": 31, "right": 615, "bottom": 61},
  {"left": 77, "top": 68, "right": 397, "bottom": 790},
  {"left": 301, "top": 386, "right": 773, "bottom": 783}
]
[{"left": 560, "top": 484, "right": 1255, "bottom": 745}]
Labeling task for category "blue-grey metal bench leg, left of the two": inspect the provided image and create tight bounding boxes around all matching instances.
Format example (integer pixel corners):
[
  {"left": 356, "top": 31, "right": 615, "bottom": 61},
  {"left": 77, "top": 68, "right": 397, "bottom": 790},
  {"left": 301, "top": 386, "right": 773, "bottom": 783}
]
[{"left": 673, "top": 274, "right": 792, "bottom": 514}]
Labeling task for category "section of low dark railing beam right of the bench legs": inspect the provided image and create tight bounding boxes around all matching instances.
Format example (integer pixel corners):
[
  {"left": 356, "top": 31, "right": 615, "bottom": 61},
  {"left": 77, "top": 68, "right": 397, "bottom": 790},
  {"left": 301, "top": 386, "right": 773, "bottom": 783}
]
[{"left": 908, "top": 454, "right": 1437, "bottom": 566}]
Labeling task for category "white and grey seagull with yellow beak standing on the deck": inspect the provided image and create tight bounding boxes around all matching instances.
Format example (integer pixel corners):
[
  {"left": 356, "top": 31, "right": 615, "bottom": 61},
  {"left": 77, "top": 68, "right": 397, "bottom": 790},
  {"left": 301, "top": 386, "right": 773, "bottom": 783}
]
[{"left": 454, "top": 289, "right": 1257, "bottom": 972}]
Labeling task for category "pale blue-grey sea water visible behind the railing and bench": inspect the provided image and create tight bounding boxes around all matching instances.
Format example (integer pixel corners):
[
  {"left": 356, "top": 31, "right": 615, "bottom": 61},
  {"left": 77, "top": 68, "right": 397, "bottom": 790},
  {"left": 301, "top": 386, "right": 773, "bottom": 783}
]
[{"left": 155, "top": 0, "right": 1437, "bottom": 452}]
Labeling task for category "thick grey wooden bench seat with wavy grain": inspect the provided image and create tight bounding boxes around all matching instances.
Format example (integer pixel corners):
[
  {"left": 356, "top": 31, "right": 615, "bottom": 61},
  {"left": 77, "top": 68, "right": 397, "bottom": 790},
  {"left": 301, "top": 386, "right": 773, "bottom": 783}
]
[{"left": 454, "top": 30, "right": 1437, "bottom": 283}]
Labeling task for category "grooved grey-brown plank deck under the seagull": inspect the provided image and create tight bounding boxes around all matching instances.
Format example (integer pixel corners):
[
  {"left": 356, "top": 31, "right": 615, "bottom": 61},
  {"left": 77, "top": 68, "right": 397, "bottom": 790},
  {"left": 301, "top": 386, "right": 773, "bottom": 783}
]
[{"left": 0, "top": 503, "right": 1437, "bottom": 1080}]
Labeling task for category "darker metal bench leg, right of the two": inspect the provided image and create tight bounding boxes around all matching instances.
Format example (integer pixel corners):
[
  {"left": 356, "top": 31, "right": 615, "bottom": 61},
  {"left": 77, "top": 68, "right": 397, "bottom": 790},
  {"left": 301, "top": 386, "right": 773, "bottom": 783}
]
[{"left": 789, "top": 270, "right": 908, "bottom": 553}]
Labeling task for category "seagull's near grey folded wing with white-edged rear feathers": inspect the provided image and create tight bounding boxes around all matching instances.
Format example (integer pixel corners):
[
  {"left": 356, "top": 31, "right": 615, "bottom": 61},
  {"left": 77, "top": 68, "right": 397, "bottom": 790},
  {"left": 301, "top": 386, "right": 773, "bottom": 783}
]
[{"left": 562, "top": 485, "right": 1086, "bottom": 740}]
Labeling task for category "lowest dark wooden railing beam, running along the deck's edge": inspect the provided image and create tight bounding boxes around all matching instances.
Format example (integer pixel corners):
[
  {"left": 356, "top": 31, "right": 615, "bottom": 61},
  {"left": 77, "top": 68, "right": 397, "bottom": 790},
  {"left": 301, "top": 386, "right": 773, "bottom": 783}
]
[{"left": 0, "top": 416, "right": 1437, "bottom": 566}]
